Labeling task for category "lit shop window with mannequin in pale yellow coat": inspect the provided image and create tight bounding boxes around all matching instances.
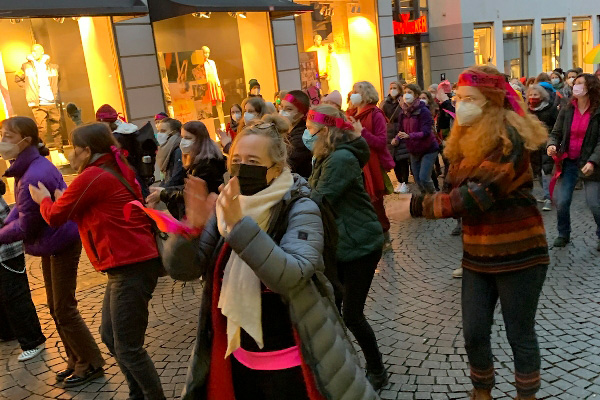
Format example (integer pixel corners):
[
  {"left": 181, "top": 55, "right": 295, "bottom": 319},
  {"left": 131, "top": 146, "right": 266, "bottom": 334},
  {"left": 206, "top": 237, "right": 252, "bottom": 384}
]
[{"left": 154, "top": 12, "right": 277, "bottom": 138}]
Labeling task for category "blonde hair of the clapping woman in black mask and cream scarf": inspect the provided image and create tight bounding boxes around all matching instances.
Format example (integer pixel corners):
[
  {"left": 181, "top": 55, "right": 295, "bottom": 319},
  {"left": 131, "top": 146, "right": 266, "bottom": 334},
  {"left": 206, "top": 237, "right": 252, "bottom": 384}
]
[{"left": 227, "top": 114, "right": 291, "bottom": 169}]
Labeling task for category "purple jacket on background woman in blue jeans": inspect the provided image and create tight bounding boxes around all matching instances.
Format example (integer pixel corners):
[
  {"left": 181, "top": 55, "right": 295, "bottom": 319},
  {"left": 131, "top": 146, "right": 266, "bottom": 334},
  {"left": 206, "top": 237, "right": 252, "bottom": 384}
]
[{"left": 398, "top": 100, "right": 439, "bottom": 155}]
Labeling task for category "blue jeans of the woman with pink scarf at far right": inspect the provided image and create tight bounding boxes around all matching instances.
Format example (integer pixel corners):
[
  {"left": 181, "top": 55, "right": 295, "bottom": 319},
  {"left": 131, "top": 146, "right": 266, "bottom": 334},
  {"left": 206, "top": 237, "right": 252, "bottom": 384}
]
[{"left": 554, "top": 159, "right": 600, "bottom": 238}]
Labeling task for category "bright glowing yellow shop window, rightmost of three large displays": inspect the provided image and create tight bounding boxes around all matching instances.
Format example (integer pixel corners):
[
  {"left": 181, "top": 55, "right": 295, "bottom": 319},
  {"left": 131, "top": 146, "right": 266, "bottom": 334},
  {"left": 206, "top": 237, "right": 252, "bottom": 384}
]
[{"left": 295, "top": 0, "right": 381, "bottom": 105}]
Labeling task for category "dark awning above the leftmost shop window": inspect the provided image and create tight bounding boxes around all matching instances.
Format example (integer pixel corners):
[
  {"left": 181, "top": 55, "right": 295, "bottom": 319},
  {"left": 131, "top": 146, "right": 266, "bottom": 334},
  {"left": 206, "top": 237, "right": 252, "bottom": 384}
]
[{"left": 0, "top": 0, "right": 148, "bottom": 18}]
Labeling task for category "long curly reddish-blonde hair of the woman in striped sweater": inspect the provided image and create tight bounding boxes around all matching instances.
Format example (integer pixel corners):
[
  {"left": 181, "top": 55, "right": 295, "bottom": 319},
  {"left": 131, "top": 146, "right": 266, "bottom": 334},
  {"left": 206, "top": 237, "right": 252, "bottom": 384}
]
[{"left": 444, "top": 66, "right": 548, "bottom": 163}]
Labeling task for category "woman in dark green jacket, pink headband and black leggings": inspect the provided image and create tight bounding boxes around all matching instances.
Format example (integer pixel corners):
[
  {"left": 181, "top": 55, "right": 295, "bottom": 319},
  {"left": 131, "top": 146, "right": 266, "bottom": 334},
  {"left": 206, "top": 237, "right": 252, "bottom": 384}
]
[{"left": 303, "top": 105, "right": 388, "bottom": 389}]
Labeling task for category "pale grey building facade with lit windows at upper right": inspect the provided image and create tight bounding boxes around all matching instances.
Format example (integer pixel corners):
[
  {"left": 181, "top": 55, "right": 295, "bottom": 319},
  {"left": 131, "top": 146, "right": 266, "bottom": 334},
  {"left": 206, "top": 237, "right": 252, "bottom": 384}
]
[{"left": 429, "top": 0, "right": 600, "bottom": 82}]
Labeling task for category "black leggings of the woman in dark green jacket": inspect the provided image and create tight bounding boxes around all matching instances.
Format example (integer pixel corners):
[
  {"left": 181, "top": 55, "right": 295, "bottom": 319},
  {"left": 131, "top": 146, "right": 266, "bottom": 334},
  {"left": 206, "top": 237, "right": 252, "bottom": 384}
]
[{"left": 336, "top": 249, "right": 384, "bottom": 373}]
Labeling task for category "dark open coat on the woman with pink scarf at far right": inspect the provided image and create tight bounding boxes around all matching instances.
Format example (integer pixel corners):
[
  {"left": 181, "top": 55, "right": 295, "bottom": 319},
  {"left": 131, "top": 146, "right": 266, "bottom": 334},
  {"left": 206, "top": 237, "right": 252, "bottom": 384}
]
[{"left": 548, "top": 102, "right": 600, "bottom": 181}]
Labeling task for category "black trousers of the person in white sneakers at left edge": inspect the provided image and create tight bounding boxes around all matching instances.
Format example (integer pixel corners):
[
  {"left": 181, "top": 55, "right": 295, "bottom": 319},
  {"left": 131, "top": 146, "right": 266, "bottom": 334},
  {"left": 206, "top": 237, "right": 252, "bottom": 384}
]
[{"left": 0, "top": 254, "right": 46, "bottom": 351}]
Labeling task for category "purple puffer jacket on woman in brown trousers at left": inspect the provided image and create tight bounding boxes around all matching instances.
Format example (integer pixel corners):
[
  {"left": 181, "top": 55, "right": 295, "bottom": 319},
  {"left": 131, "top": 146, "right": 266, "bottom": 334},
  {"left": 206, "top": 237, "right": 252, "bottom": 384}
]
[{"left": 0, "top": 146, "right": 80, "bottom": 256}]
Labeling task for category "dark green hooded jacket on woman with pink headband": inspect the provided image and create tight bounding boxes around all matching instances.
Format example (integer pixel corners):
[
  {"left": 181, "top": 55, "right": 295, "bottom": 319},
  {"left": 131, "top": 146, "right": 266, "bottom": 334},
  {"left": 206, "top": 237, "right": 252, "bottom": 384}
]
[{"left": 309, "top": 137, "right": 383, "bottom": 262}]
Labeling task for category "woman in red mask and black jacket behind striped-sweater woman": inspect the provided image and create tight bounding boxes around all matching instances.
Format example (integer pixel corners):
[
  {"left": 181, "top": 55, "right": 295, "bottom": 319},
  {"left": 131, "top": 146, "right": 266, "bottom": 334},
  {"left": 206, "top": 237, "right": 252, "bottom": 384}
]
[{"left": 527, "top": 84, "right": 558, "bottom": 211}]
